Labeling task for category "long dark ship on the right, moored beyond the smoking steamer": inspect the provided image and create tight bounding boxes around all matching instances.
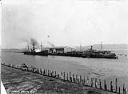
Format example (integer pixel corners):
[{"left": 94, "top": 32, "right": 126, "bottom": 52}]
[{"left": 50, "top": 46, "right": 118, "bottom": 59}]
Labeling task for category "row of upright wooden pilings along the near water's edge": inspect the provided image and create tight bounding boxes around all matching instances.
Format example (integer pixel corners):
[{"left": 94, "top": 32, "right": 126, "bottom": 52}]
[{"left": 2, "top": 63, "right": 127, "bottom": 94}]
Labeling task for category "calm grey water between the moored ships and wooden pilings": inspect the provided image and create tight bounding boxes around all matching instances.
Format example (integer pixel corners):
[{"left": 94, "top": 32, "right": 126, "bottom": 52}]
[{"left": 2, "top": 52, "right": 128, "bottom": 87}]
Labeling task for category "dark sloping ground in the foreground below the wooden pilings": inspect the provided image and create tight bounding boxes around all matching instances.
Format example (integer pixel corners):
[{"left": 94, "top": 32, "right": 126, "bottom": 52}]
[{"left": 1, "top": 65, "right": 117, "bottom": 94}]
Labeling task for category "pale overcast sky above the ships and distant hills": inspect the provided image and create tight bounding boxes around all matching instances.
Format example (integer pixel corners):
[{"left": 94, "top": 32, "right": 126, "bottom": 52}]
[{"left": 1, "top": 0, "right": 128, "bottom": 48}]
